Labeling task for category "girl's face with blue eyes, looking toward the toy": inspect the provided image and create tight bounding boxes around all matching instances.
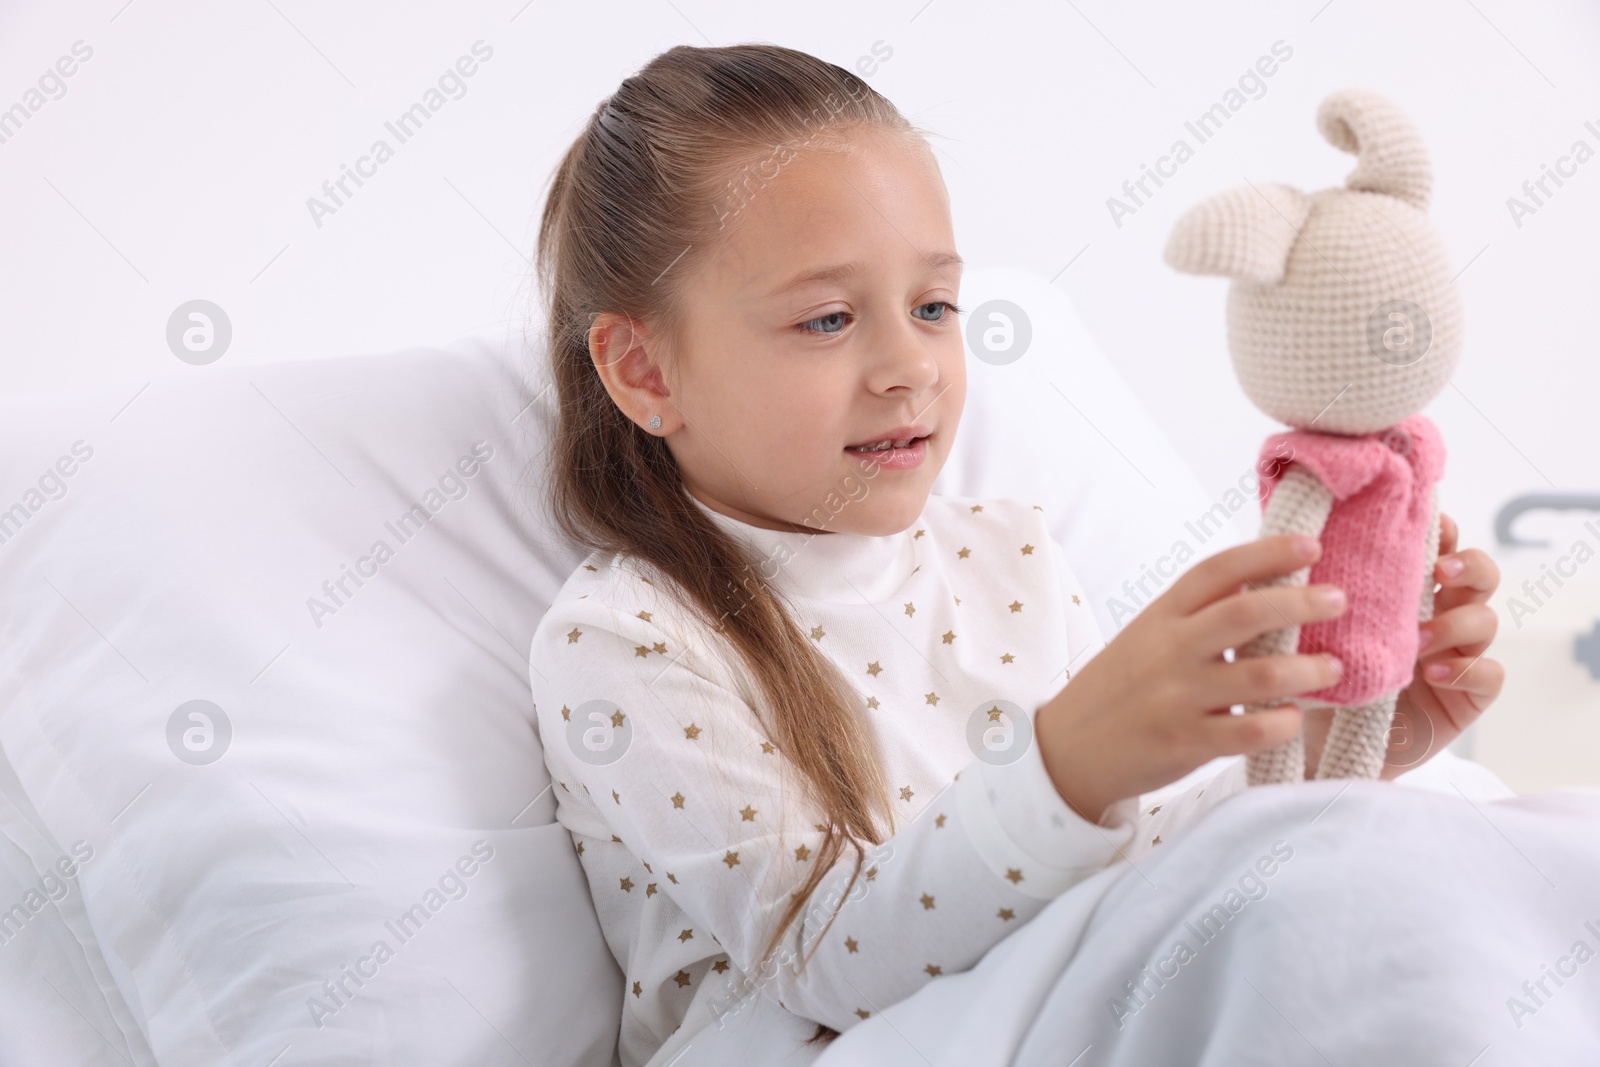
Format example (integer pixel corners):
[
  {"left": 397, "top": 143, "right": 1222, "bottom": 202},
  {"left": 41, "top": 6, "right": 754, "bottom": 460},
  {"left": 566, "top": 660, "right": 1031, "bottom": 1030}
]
[{"left": 602, "top": 128, "right": 966, "bottom": 534}]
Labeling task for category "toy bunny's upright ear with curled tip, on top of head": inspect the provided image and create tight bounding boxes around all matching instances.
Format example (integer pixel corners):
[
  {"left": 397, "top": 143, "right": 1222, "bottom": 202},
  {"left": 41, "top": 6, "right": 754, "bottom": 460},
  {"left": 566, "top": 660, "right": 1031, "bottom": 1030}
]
[{"left": 1317, "top": 90, "right": 1434, "bottom": 211}]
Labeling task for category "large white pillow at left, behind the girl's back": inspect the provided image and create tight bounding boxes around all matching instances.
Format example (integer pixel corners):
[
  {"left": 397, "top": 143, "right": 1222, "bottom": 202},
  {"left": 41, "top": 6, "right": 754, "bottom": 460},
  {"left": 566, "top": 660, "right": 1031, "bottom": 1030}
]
[{"left": 0, "top": 335, "right": 622, "bottom": 1067}]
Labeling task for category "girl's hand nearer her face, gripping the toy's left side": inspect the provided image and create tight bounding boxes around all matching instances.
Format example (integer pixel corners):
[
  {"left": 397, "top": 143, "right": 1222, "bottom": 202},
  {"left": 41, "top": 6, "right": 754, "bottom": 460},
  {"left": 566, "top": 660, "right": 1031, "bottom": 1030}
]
[{"left": 1035, "top": 530, "right": 1350, "bottom": 822}]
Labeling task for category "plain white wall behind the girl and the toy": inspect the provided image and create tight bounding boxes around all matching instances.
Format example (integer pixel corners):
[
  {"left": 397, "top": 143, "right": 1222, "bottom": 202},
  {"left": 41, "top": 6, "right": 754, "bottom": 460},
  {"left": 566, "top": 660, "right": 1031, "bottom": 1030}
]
[{"left": 0, "top": 0, "right": 1600, "bottom": 544}]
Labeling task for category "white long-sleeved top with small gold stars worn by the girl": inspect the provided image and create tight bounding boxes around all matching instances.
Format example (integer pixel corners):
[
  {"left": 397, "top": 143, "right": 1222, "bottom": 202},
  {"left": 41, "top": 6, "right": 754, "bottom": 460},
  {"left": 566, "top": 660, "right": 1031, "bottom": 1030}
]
[{"left": 530, "top": 496, "right": 1243, "bottom": 1067}]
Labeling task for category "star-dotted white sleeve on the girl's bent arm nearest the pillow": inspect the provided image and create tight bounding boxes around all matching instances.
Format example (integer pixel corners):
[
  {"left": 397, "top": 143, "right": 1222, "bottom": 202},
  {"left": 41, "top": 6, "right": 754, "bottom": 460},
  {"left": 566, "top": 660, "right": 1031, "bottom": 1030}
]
[{"left": 531, "top": 573, "right": 1136, "bottom": 1040}]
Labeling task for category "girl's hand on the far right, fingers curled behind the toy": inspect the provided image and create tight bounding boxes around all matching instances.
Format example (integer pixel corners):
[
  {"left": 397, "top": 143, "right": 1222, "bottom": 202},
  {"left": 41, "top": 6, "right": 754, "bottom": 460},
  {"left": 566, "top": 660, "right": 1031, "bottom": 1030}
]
[{"left": 1382, "top": 512, "right": 1506, "bottom": 779}]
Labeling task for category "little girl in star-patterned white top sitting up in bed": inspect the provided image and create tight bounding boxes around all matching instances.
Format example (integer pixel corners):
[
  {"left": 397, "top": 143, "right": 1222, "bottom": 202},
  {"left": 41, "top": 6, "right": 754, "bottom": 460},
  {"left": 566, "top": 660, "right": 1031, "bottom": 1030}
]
[{"left": 531, "top": 45, "right": 1498, "bottom": 1067}]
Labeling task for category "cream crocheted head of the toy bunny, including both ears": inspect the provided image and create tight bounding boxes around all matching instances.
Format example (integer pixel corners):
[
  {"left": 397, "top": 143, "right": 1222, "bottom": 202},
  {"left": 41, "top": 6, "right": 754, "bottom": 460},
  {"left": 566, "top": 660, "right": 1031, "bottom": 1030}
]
[{"left": 1165, "top": 90, "right": 1462, "bottom": 435}]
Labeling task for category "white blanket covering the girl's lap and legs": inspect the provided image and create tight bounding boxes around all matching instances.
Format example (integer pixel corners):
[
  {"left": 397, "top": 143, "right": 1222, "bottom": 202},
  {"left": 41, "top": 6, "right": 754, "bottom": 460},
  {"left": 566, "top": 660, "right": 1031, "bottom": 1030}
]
[{"left": 677, "top": 761, "right": 1600, "bottom": 1067}]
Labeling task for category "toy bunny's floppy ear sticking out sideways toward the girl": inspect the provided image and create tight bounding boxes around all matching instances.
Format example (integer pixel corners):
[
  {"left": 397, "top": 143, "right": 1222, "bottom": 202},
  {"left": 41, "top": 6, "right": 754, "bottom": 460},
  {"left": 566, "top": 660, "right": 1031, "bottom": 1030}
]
[{"left": 1166, "top": 184, "right": 1310, "bottom": 285}]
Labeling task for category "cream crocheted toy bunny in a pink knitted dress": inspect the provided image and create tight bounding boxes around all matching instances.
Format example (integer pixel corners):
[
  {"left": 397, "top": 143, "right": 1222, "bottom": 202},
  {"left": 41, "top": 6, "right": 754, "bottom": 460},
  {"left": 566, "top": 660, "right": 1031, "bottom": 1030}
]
[{"left": 1166, "top": 90, "right": 1461, "bottom": 785}]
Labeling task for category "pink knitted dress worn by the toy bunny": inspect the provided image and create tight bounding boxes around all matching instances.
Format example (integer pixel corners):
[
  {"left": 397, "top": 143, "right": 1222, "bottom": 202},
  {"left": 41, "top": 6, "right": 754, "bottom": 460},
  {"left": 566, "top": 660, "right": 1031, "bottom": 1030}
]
[{"left": 1258, "top": 414, "right": 1445, "bottom": 707}]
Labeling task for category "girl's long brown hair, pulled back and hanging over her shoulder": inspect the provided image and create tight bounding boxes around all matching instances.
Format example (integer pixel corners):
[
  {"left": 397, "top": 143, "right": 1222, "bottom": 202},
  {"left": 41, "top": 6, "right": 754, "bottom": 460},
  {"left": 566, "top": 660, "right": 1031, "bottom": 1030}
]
[{"left": 538, "top": 45, "right": 926, "bottom": 1041}]
